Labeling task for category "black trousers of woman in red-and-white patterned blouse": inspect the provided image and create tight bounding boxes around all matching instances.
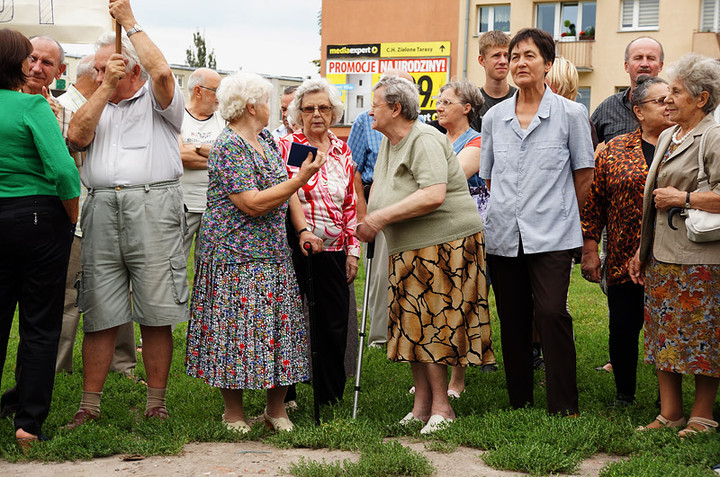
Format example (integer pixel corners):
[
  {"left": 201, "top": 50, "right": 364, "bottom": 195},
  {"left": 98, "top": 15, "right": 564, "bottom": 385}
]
[{"left": 293, "top": 247, "right": 350, "bottom": 404}]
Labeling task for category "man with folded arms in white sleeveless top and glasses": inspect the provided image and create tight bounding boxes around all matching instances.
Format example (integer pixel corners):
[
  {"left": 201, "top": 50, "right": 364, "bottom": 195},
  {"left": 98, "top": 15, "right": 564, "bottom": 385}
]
[{"left": 180, "top": 68, "right": 225, "bottom": 258}]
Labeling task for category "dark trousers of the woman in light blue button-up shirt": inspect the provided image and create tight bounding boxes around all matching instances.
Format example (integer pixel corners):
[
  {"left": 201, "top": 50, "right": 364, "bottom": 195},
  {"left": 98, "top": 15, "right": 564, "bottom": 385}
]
[{"left": 487, "top": 245, "right": 578, "bottom": 414}]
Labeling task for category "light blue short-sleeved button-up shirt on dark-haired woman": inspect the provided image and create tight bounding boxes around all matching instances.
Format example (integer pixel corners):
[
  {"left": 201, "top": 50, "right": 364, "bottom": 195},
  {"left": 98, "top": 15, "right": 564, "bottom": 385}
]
[{"left": 479, "top": 87, "right": 595, "bottom": 257}]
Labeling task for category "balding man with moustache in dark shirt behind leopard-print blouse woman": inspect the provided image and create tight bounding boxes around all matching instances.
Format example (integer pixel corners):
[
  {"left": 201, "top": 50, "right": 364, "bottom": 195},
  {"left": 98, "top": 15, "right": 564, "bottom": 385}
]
[{"left": 590, "top": 36, "right": 665, "bottom": 143}]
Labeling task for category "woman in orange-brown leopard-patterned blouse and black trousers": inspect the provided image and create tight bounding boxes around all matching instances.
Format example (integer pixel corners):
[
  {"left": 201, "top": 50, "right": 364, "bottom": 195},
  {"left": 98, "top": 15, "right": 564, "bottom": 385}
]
[{"left": 582, "top": 75, "right": 673, "bottom": 406}]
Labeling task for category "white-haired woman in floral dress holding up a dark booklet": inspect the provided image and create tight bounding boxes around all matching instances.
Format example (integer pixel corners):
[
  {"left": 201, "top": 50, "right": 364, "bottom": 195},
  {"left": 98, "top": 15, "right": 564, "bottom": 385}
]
[{"left": 185, "top": 73, "right": 325, "bottom": 433}]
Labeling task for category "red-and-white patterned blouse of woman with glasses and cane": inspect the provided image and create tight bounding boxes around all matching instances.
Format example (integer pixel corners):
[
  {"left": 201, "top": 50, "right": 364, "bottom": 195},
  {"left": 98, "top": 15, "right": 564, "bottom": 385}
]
[{"left": 279, "top": 131, "right": 360, "bottom": 257}]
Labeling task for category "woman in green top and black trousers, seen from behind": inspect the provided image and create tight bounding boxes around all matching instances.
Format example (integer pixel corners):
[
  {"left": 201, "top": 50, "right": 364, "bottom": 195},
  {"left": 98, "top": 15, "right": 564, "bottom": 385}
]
[{"left": 0, "top": 29, "right": 80, "bottom": 449}]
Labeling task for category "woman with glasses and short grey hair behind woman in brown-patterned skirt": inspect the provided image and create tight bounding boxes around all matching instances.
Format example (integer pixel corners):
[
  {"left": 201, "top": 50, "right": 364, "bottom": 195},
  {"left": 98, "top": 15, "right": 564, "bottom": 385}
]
[{"left": 435, "top": 80, "right": 497, "bottom": 398}]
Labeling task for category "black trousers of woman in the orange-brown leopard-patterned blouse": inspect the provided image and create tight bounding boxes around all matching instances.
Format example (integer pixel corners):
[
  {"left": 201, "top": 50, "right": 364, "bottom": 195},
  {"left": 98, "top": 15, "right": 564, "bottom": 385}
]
[{"left": 608, "top": 282, "right": 645, "bottom": 401}]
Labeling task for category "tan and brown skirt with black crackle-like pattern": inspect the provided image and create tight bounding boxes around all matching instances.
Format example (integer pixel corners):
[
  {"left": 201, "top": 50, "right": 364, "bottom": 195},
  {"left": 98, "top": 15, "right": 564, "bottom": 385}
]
[{"left": 387, "top": 232, "right": 492, "bottom": 366}]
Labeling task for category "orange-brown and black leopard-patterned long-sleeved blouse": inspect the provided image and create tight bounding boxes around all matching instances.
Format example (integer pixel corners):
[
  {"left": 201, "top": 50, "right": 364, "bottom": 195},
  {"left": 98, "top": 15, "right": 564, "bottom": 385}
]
[{"left": 582, "top": 129, "right": 648, "bottom": 285}]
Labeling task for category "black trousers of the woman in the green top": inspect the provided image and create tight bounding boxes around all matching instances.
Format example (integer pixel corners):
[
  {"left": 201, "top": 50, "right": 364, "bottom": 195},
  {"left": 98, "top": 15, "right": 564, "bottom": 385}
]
[{"left": 0, "top": 196, "right": 73, "bottom": 435}]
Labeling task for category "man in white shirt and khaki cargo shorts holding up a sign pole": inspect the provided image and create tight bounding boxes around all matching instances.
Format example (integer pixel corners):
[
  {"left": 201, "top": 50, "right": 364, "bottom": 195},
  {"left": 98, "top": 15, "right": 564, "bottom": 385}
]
[{"left": 68, "top": 0, "right": 188, "bottom": 428}]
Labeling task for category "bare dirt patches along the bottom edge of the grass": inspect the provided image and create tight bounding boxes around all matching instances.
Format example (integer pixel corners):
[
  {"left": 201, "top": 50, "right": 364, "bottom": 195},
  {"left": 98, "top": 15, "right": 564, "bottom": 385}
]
[{"left": 0, "top": 439, "right": 620, "bottom": 477}]
